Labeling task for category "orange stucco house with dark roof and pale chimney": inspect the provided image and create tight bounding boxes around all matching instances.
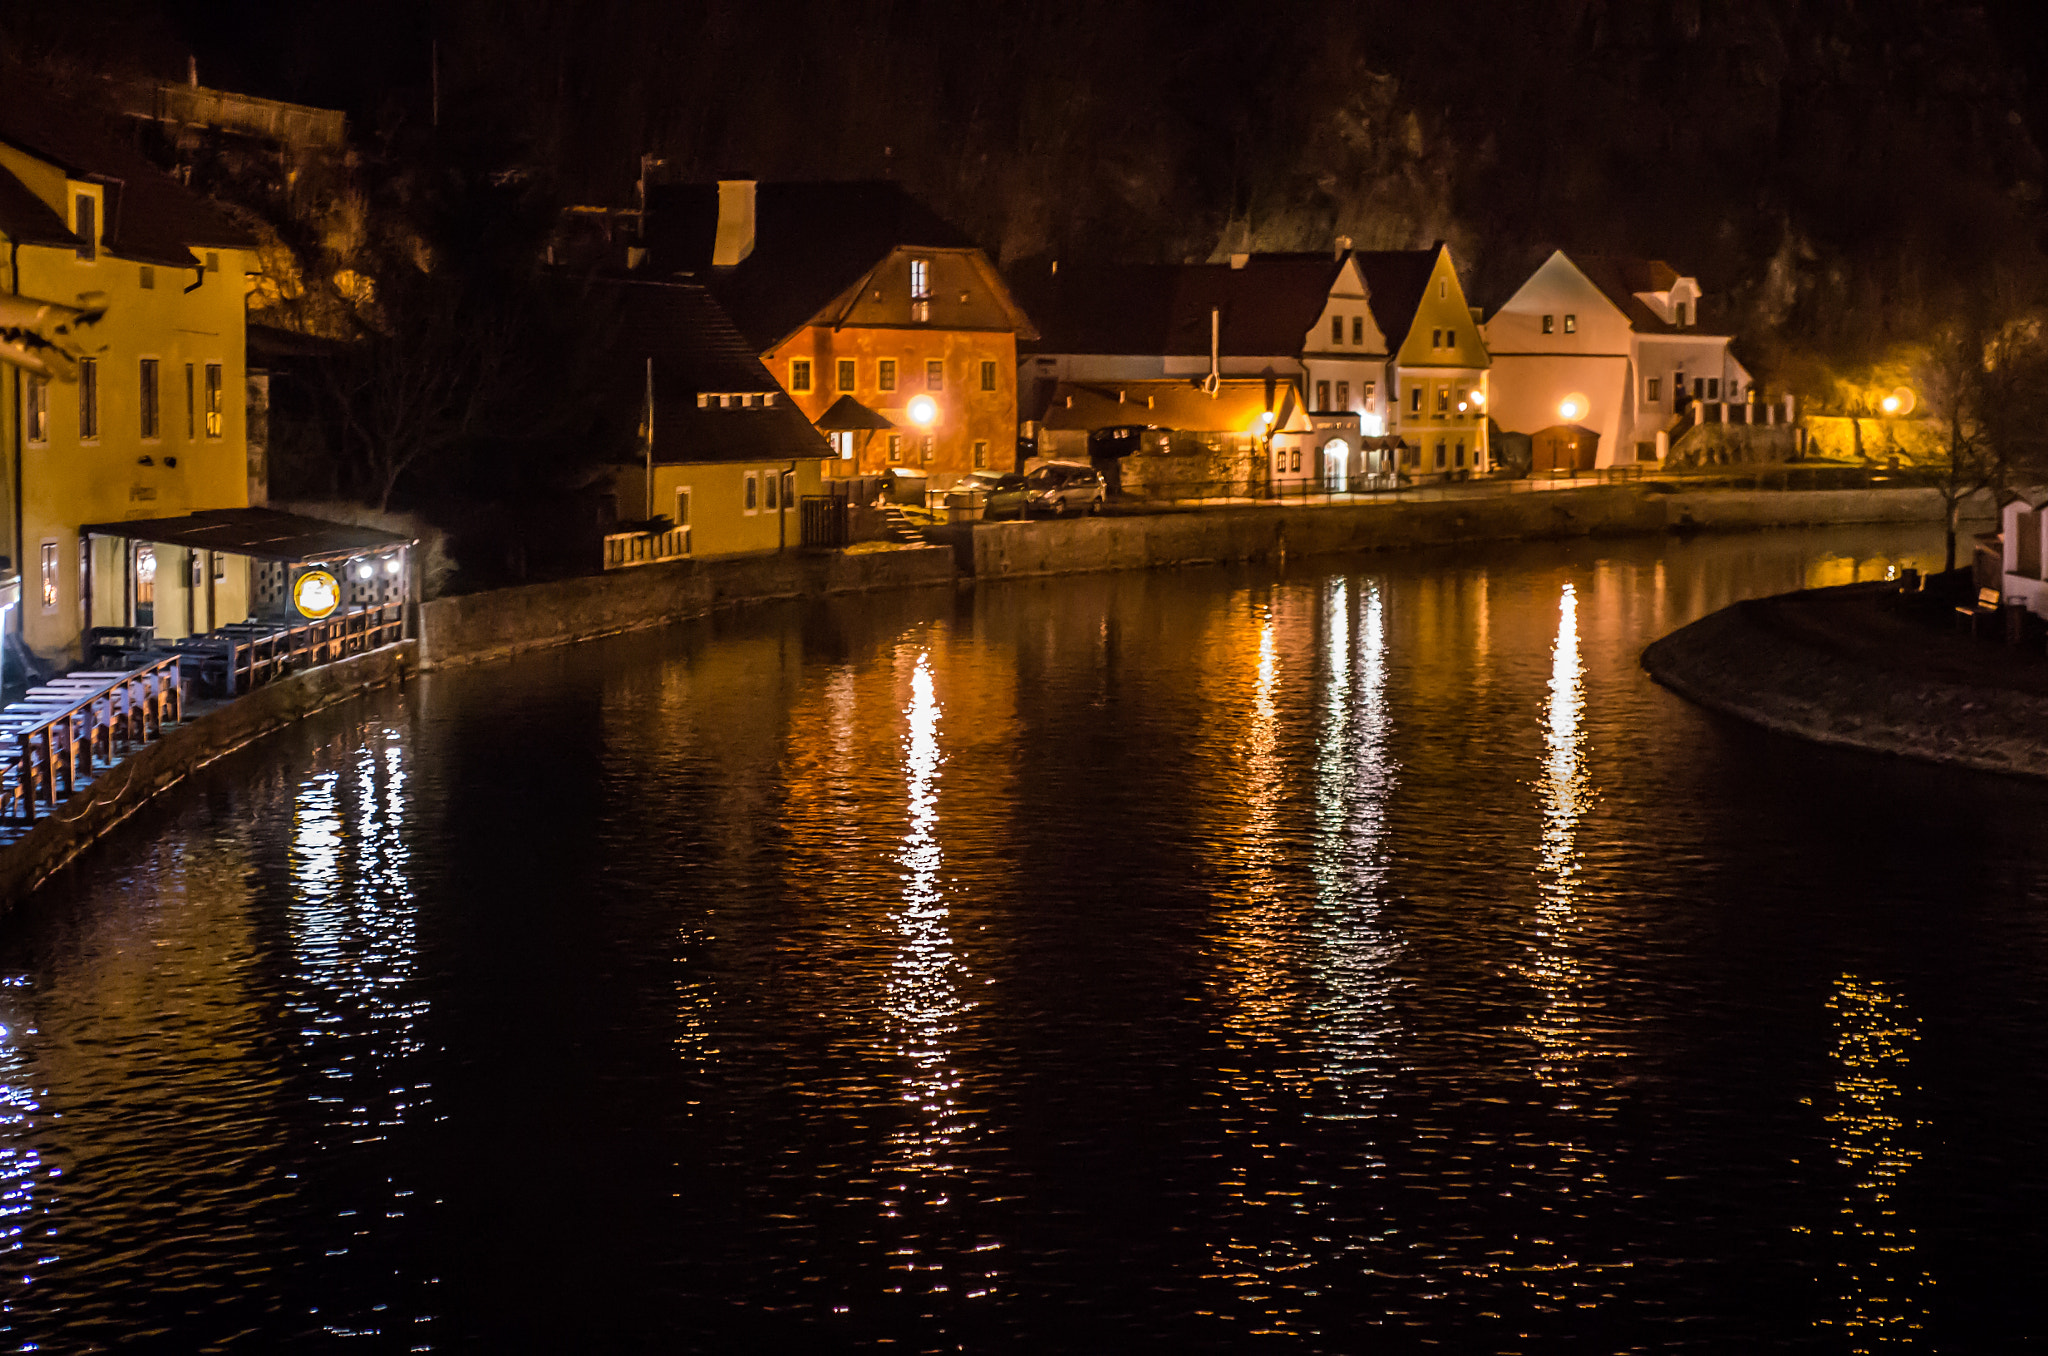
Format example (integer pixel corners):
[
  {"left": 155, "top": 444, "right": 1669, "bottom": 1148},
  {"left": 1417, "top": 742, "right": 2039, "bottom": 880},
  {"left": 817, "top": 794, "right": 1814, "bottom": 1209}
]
[{"left": 647, "top": 180, "right": 1038, "bottom": 488}]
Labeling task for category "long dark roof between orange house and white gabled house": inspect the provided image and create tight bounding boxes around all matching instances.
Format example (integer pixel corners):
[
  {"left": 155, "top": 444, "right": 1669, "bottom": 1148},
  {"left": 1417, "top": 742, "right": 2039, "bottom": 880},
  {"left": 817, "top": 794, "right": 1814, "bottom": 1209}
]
[{"left": 1018, "top": 254, "right": 1339, "bottom": 358}]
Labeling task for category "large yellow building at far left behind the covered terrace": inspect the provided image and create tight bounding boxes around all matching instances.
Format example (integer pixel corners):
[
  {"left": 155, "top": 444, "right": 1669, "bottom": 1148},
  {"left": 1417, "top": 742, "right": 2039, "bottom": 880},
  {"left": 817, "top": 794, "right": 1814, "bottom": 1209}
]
[{"left": 0, "top": 80, "right": 256, "bottom": 664}]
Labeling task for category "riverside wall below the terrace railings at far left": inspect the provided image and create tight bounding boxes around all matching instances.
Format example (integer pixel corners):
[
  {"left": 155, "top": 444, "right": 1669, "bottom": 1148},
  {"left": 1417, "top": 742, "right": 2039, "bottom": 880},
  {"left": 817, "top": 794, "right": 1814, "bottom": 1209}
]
[{"left": 0, "top": 641, "right": 418, "bottom": 909}]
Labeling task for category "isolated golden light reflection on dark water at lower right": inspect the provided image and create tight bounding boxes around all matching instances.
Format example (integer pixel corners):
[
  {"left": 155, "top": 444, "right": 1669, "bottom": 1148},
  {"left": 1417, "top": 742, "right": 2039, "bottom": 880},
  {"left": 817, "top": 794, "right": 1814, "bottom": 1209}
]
[{"left": 1821, "top": 975, "right": 1933, "bottom": 1354}]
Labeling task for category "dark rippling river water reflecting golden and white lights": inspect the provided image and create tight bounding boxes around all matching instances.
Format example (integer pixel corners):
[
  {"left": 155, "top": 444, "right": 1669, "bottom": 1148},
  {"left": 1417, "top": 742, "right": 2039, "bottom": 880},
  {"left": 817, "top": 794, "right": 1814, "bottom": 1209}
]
[{"left": 0, "top": 528, "right": 2048, "bottom": 1354}]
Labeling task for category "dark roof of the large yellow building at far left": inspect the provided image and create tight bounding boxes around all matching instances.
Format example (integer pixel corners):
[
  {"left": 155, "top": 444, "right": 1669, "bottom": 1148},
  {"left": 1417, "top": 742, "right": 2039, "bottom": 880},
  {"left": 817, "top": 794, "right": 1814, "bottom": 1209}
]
[{"left": 0, "top": 70, "right": 256, "bottom": 268}]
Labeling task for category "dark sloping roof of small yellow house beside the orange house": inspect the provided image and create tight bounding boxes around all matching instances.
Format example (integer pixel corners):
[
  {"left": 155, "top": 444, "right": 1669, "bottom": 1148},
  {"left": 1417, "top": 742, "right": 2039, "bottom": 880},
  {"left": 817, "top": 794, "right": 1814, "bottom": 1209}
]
[{"left": 584, "top": 279, "right": 831, "bottom": 461}]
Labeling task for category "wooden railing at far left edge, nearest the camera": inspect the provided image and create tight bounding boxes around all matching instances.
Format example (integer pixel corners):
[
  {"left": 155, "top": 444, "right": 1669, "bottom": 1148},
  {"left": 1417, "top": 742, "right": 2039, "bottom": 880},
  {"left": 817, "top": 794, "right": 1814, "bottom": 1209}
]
[{"left": 0, "top": 655, "right": 184, "bottom": 823}]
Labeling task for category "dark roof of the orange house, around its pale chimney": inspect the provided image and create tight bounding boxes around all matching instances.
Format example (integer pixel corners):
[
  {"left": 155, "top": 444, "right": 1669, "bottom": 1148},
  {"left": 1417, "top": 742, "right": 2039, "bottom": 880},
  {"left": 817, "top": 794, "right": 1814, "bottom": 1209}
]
[{"left": 647, "top": 180, "right": 975, "bottom": 352}]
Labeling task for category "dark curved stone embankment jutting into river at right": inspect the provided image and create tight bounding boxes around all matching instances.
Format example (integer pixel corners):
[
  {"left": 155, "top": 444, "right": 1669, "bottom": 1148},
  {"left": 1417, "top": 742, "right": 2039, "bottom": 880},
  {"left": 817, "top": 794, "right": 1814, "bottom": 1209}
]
[{"left": 1642, "top": 584, "right": 2048, "bottom": 776}]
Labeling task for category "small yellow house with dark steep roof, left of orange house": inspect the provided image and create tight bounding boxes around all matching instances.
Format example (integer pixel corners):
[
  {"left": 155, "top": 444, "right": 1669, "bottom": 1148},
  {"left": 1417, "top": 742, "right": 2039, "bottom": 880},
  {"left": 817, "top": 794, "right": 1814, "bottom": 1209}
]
[{"left": 590, "top": 279, "right": 831, "bottom": 567}]
